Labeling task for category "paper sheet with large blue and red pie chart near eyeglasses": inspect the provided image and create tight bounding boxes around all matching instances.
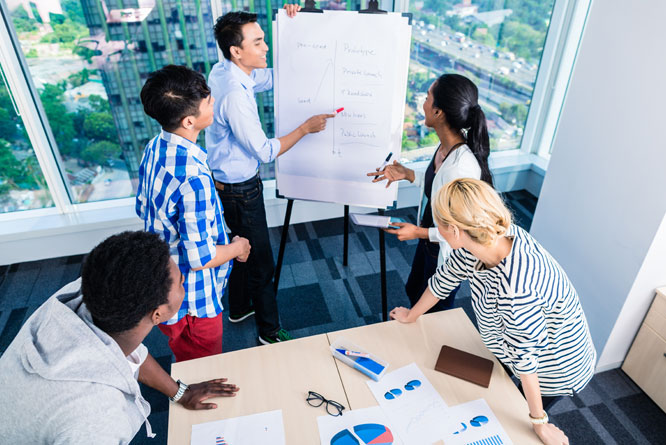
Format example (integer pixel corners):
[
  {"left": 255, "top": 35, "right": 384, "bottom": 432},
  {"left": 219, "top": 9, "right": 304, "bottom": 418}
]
[{"left": 317, "top": 406, "right": 403, "bottom": 445}]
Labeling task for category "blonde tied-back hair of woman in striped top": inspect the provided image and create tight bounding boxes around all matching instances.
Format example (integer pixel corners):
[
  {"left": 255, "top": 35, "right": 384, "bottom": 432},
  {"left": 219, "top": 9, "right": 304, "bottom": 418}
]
[{"left": 432, "top": 178, "right": 511, "bottom": 246}]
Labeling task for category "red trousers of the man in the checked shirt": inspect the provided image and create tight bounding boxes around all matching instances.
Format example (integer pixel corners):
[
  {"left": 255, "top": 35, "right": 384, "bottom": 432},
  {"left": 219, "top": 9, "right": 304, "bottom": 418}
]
[{"left": 159, "top": 313, "right": 222, "bottom": 362}]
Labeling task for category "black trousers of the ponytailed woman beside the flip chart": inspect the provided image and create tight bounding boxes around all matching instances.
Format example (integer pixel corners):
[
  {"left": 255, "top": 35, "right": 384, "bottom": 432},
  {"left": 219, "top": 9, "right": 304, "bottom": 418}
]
[{"left": 405, "top": 239, "right": 460, "bottom": 313}]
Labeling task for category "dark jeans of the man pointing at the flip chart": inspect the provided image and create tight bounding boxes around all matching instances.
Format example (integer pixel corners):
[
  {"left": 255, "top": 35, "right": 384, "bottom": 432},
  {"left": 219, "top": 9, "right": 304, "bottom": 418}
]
[{"left": 215, "top": 175, "right": 280, "bottom": 335}]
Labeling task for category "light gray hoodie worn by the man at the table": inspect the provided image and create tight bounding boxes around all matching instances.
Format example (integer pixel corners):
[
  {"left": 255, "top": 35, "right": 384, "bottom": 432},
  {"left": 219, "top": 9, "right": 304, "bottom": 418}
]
[{"left": 0, "top": 279, "right": 154, "bottom": 445}]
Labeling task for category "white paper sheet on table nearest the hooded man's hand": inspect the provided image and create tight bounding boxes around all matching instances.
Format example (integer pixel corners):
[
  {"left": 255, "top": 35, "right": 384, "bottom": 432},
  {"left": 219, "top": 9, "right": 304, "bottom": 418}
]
[{"left": 190, "top": 409, "right": 286, "bottom": 445}]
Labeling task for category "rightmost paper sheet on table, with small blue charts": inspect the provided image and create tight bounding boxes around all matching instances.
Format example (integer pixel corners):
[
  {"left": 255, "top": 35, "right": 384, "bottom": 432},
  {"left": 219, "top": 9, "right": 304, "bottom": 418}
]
[{"left": 444, "top": 399, "right": 513, "bottom": 445}]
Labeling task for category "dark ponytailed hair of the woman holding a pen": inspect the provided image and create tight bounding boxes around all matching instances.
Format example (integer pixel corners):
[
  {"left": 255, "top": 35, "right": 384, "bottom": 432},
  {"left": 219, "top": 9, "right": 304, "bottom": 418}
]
[{"left": 432, "top": 74, "right": 493, "bottom": 186}]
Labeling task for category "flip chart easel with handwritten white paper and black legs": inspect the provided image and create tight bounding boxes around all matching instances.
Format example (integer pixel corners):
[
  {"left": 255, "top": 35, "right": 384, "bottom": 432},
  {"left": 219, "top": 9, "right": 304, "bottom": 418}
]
[{"left": 273, "top": 1, "right": 411, "bottom": 320}]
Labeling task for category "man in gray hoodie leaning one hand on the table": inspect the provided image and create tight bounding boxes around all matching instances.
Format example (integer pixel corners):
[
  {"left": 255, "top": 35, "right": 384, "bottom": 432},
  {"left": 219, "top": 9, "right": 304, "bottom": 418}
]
[{"left": 0, "top": 232, "right": 238, "bottom": 445}]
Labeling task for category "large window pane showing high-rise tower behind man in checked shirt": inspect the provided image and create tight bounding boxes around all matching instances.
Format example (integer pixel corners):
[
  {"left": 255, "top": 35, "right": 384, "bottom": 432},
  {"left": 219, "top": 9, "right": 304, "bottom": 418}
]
[{"left": 11, "top": 0, "right": 217, "bottom": 202}]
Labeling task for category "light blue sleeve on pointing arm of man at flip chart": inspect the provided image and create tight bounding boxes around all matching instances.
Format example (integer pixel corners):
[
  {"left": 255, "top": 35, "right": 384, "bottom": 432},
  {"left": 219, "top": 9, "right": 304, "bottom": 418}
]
[{"left": 223, "top": 91, "right": 280, "bottom": 164}]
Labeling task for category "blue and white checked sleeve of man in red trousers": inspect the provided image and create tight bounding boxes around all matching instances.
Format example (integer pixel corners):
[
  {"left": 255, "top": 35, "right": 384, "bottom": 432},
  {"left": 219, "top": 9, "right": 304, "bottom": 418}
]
[{"left": 177, "top": 177, "right": 216, "bottom": 269}]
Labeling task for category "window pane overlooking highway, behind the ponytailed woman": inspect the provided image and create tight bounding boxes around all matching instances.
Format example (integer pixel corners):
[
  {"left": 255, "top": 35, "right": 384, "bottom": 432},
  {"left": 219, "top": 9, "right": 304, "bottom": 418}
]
[{"left": 403, "top": 0, "right": 554, "bottom": 161}]
